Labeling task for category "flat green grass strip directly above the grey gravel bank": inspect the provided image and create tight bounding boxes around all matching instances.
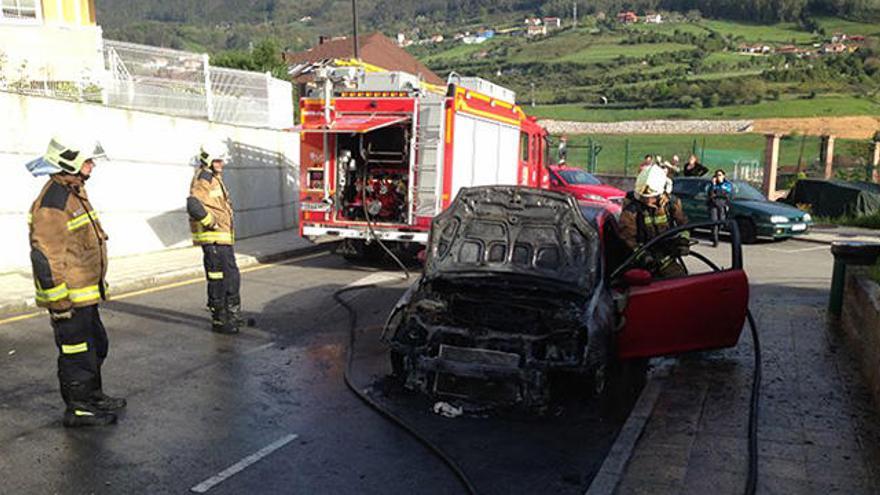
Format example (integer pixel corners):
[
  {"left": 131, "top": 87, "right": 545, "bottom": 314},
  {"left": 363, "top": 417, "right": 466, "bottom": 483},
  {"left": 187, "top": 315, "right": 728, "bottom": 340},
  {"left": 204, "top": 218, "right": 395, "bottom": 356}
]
[{"left": 525, "top": 96, "right": 880, "bottom": 122}]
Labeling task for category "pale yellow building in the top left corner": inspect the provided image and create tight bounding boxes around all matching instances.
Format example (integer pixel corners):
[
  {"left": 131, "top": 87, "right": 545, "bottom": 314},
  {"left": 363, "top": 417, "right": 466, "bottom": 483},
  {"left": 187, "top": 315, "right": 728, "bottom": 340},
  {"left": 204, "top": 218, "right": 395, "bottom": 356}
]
[{"left": 0, "top": 0, "right": 104, "bottom": 84}]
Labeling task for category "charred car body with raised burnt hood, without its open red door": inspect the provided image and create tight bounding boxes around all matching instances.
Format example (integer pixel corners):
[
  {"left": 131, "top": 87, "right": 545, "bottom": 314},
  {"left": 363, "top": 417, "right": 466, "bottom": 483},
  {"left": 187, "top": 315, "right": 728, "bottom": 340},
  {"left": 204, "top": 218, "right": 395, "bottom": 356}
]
[{"left": 384, "top": 186, "right": 615, "bottom": 407}]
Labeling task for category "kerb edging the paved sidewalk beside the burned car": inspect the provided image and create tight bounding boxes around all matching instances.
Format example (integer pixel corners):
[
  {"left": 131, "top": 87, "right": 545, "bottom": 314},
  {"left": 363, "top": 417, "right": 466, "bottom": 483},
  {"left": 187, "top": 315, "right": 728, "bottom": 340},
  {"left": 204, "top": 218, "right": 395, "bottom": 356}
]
[{"left": 585, "top": 377, "right": 664, "bottom": 495}]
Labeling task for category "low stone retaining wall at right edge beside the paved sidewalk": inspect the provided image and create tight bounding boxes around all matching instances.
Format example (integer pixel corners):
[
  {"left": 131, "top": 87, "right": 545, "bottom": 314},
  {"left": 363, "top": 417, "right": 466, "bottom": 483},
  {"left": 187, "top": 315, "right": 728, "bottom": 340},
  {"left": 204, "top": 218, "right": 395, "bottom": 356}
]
[{"left": 841, "top": 267, "right": 880, "bottom": 409}]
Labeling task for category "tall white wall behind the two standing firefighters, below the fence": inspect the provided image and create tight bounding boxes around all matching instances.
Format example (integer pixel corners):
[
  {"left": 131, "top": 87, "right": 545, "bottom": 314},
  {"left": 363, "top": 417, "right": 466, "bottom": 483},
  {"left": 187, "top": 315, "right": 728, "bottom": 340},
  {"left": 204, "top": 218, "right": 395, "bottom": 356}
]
[{"left": 0, "top": 92, "right": 300, "bottom": 272}]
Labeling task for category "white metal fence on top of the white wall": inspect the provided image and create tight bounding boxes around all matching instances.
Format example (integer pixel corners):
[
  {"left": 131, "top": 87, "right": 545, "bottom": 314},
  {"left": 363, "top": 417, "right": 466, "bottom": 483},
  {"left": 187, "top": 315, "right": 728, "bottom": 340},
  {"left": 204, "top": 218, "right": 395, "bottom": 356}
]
[{"left": 0, "top": 40, "right": 294, "bottom": 128}]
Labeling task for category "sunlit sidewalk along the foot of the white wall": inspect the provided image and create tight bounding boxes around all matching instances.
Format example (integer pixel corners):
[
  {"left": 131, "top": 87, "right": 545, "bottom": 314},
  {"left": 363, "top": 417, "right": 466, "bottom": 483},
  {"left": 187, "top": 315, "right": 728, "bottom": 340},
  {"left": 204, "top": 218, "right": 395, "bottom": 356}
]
[{"left": 0, "top": 230, "right": 330, "bottom": 315}]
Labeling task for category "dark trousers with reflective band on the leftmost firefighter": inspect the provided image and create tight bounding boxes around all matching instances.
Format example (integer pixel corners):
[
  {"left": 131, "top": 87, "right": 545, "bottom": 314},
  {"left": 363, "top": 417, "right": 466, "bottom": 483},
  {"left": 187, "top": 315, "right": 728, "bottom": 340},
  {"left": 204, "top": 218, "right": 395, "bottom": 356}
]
[{"left": 52, "top": 304, "right": 109, "bottom": 407}]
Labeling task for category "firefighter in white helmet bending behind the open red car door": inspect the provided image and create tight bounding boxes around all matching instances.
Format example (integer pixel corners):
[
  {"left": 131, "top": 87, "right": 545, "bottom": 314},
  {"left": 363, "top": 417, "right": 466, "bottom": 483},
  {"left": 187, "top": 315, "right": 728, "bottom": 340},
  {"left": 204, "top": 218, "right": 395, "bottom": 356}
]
[{"left": 618, "top": 165, "right": 691, "bottom": 278}]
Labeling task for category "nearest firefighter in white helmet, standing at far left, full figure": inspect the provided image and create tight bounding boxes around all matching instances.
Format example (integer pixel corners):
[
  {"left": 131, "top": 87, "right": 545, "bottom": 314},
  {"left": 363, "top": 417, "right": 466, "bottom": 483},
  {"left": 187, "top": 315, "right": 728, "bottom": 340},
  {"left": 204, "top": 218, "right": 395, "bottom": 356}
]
[{"left": 27, "top": 137, "right": 126, "bottom": 427}]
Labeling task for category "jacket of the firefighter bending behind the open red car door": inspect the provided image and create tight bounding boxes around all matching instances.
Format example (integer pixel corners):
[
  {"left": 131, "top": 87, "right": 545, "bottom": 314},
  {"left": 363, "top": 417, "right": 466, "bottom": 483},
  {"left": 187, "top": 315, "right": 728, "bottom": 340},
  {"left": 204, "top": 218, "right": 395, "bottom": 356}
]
[{"left": 618, "top": 192, "right": 688, "bottom": 250}]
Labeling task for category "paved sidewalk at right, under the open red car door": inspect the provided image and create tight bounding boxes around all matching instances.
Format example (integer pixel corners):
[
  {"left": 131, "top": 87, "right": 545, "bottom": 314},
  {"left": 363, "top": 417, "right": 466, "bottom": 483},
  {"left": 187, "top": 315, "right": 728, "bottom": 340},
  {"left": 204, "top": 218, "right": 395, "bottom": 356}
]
[{"left": 588, "top": 260, "right": 880, "bottom": 495}]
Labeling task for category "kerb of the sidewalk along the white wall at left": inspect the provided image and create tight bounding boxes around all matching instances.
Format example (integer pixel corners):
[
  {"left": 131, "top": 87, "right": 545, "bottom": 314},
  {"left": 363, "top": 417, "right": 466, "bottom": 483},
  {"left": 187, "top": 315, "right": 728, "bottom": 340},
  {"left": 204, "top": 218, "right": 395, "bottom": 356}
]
[{"left": 0, "top": 241, "right": 340, "bottom": 316}]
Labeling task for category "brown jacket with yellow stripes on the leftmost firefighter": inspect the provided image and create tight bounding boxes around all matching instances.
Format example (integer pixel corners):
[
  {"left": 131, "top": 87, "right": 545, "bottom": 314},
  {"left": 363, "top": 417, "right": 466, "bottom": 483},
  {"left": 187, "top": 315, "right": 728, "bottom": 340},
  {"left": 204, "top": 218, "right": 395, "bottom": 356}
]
[{"left": 28, "top": 174, "right": 107, "bottom": 311}]
